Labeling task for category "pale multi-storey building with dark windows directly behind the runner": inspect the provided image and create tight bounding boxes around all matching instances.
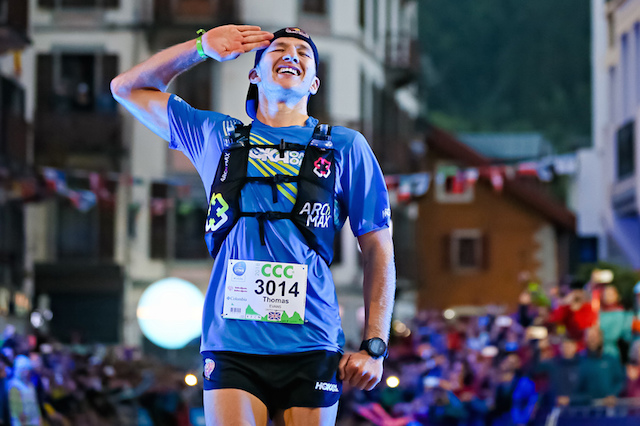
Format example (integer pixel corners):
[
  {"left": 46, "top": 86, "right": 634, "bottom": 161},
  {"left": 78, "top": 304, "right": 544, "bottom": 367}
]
[{"left": 24, "top": 0, "right": 419, "bottom": 345}]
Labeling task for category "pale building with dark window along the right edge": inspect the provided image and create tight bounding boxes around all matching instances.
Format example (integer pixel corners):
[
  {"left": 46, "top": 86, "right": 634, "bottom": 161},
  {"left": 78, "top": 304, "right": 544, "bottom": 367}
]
[{"left": 592, "top": 0, "right": 640, "bottom": 269}]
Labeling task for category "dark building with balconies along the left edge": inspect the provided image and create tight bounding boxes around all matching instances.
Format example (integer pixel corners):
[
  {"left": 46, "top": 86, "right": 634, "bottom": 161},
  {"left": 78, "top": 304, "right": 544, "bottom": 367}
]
[{"left": 0, "top": 0, "right": 34, "bottom": 331}]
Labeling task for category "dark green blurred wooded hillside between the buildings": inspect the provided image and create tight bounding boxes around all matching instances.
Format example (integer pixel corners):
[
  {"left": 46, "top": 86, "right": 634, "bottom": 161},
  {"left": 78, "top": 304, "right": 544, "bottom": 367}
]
[{"left": 419, "top": 0, "right": 591, "bottom": 150}]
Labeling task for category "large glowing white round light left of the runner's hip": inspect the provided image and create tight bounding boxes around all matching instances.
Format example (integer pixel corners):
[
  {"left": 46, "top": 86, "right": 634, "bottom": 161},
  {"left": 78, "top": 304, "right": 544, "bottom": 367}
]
[{"left": 136, "top": 277, "right": 204, "bottom": 349}]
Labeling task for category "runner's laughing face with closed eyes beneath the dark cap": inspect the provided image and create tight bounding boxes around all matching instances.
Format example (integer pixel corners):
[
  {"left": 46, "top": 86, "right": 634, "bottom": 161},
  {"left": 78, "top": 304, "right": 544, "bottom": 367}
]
[{"left": 256, "top": 37, "right": 319, "bottom": 95}]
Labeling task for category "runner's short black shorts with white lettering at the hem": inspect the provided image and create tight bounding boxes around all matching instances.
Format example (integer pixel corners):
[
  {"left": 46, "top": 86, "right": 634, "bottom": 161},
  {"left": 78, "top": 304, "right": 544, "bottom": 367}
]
[{"left": 202, "top": 351, "right": 342, "bottom": 416}]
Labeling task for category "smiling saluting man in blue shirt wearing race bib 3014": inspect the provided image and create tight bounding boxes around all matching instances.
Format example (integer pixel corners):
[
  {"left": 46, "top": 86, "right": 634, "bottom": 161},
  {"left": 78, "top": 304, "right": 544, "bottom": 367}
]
[{"left": 111, "top": 25, "right": 395, "bottom": 425}]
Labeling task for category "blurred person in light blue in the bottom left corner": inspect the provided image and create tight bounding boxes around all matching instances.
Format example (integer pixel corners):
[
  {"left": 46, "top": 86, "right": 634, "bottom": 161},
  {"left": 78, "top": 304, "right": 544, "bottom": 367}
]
[{"left": 8, "top": 355, "right": 42, "bottom": 426}]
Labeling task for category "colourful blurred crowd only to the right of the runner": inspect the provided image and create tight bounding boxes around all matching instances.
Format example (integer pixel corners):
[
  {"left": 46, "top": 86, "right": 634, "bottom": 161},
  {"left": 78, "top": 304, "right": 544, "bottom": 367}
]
[{"left": 340, "top": 282, "right": 640, "bottom": 426}]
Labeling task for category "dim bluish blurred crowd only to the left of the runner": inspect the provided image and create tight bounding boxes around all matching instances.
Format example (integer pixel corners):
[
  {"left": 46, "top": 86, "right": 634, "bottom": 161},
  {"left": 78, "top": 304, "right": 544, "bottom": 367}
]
[{"left": 0, "top": 325, "right": 201, "bottom": 426}]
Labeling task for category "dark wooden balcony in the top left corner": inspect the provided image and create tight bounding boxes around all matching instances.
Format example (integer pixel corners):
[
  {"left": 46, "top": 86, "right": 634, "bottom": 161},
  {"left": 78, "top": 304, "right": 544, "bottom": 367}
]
[{"left": 0, "top": 0, "right": 30, "bottom": 55}]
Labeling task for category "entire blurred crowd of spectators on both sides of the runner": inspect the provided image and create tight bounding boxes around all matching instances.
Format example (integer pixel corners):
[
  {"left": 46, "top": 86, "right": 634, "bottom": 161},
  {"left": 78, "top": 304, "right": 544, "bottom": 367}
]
[{"left": 0, "top": 272, "right": 640, "bottom": 426}]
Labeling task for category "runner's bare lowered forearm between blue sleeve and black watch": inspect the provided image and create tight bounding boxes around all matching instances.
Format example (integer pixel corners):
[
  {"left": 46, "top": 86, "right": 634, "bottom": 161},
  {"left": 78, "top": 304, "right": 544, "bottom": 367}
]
[{"left": 359, "top": 229, "right": 396, "bottom": 341}]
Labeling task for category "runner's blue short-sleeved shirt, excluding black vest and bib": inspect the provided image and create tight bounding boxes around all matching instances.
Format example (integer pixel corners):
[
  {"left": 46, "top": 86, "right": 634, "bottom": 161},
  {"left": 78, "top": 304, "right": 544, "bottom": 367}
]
[{"left": 168, "top": 96, "right": 390, "bottom": 354}]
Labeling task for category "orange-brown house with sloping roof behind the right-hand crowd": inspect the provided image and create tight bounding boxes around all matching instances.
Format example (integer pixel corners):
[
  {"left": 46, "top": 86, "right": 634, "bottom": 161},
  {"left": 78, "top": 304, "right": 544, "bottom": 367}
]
[{"left": 416, "top": 127, "right": 575, "bottom": 311}]
